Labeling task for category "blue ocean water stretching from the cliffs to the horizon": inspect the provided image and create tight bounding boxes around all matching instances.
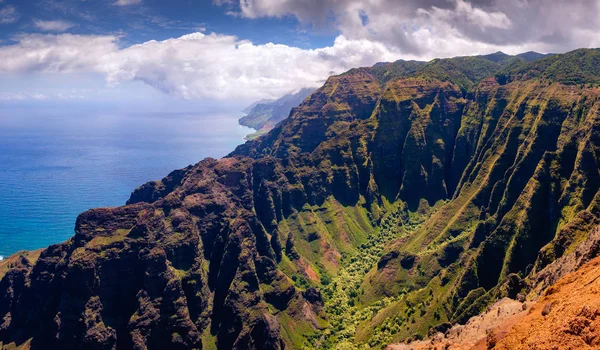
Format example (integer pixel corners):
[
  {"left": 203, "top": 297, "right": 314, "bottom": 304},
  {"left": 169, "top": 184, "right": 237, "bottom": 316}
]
[{"left": 0, "top": 109, "right": 252, "bottom": 257}]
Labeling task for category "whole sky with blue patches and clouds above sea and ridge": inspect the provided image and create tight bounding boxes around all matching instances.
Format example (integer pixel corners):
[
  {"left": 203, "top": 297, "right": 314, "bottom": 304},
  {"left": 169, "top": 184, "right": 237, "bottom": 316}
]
[{"left": 0, "top": 0, "right": 600, "bottom": 107}]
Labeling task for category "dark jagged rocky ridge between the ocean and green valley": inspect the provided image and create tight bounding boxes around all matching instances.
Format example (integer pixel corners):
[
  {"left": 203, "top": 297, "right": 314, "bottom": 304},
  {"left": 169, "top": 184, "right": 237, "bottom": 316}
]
[{"left": 0, "top": 158, "right": 326, "bottom": 349}]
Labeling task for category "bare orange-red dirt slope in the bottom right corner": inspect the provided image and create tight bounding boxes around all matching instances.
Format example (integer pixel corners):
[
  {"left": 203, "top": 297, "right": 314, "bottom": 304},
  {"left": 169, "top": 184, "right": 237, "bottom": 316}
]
[{"left": 388, "top": 257, "right": 600, "bottom": 350}]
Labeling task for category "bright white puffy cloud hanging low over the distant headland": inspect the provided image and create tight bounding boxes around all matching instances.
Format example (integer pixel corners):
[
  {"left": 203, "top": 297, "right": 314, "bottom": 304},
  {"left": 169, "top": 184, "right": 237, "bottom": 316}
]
[{"left": 100, "top": 33, "right": 396, "bottom": 99}]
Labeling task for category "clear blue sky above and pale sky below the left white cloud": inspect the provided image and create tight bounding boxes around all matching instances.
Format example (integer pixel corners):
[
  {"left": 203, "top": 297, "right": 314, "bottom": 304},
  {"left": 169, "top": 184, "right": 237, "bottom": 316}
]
[{"left": 0, "top": 0, "right": 337, "bottom": 108}]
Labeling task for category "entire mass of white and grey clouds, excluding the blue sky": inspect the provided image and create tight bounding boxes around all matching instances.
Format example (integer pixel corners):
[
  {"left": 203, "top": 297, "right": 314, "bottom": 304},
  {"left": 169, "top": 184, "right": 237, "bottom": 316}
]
[{"left": 0, "top": 0, "right": 600, "bottom": 100}]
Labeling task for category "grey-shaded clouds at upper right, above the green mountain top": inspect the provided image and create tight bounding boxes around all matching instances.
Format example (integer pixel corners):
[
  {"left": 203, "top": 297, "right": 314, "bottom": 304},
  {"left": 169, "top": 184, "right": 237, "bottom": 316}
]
[{"left": 214, "top": 0, "right": 600, "bottom": 58}]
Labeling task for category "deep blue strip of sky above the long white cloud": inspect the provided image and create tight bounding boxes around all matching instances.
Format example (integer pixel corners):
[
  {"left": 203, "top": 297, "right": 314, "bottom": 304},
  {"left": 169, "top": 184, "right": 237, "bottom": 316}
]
[{"left": 0, "top": 0, "right": 337, "bottom": 48}]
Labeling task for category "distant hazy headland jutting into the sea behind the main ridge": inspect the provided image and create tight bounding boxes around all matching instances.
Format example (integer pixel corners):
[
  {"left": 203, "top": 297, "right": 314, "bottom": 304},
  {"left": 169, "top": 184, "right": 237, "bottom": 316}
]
[{"left": 239, "top": 88, "right": 314, "bottom": 139}]
